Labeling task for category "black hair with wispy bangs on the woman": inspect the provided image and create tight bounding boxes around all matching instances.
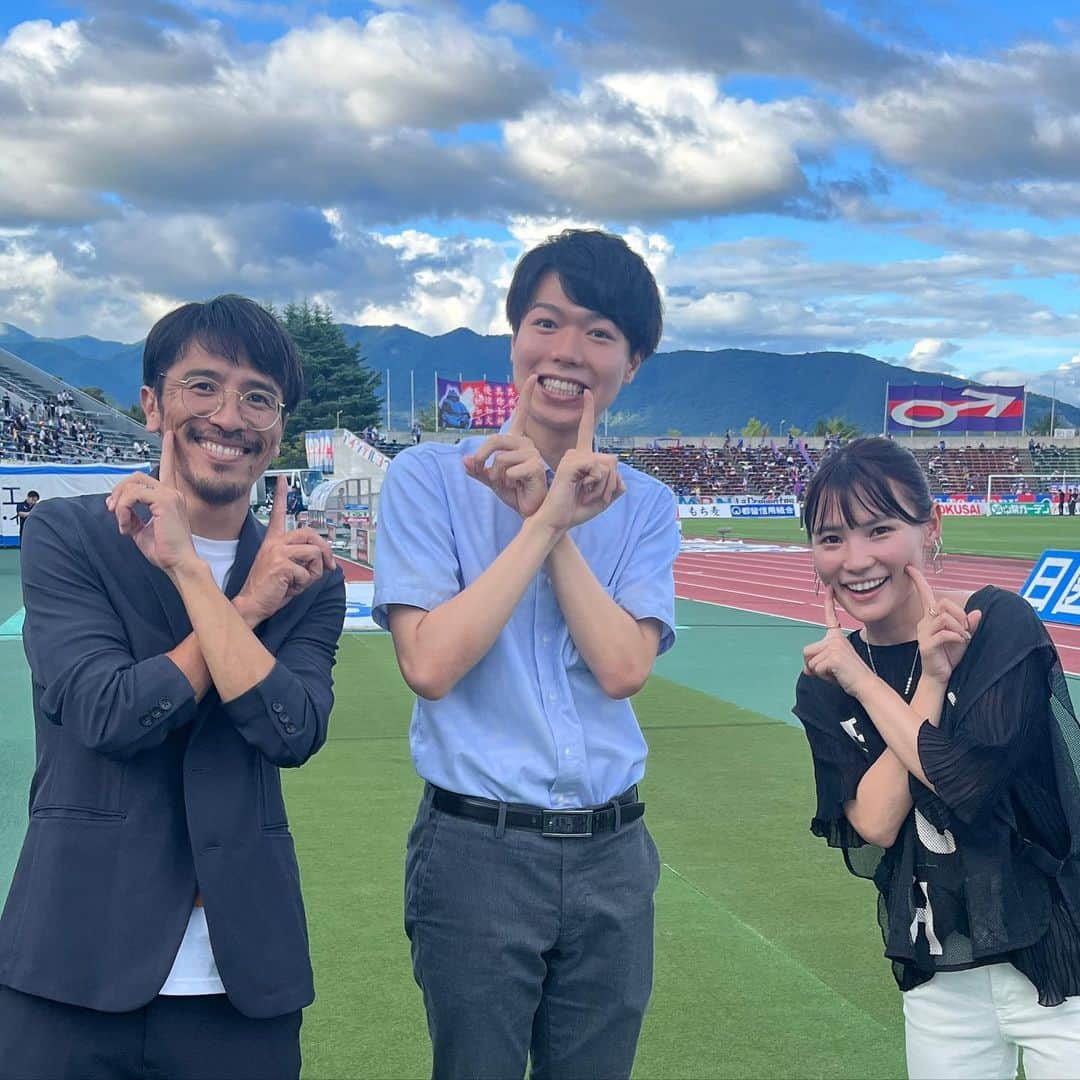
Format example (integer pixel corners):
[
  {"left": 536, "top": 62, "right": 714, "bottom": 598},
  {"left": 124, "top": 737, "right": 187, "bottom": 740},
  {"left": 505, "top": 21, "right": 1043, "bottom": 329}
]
[{"left": 802, "top": 435, "right": 933, "bottom": 537}]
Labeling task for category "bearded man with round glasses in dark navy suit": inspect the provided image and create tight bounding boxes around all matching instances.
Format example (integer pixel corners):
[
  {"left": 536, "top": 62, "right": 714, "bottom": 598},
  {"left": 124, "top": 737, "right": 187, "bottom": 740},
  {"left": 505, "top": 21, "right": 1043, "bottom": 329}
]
[{"left": 0, "top": 296, "right": 345, "bottom": 1080}]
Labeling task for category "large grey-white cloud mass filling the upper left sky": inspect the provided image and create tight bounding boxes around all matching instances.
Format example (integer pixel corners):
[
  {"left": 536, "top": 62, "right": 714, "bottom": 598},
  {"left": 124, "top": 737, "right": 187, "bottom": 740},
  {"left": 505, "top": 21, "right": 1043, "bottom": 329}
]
[{"left": 0, "top": 12, "right": 544, "bottom": 224}]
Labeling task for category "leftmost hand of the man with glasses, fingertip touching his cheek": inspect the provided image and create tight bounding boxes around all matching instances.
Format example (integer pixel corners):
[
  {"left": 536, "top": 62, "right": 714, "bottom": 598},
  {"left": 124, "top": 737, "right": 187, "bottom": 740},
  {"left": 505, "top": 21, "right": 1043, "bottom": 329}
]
[{"left": 105, "top": 431, "right": 199, "bottom": 573}]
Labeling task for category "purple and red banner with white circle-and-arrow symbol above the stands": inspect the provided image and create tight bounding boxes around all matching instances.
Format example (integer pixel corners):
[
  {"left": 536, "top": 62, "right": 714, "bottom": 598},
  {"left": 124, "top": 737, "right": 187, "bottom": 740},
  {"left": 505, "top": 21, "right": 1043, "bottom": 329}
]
[{"left": 886, "top": 384, "right": 1024, "bottom": 435}]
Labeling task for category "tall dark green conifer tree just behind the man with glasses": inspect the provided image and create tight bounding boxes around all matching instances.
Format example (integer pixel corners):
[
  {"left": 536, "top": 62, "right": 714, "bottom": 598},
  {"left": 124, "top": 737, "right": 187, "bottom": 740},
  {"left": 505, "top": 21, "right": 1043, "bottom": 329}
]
[{"left": 274, "top": 300, "right": 380, "bottom": 468}]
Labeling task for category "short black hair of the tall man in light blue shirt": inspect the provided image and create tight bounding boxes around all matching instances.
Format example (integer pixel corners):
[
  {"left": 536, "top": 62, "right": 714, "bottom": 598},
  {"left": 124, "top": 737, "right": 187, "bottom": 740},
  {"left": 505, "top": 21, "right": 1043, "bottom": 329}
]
[{"left": 507, "top": 229, "right": 663, "bottom": 360}]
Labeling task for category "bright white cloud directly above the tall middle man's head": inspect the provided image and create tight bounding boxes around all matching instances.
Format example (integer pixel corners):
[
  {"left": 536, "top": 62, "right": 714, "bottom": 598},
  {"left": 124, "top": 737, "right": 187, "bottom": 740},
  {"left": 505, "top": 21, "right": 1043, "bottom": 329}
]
[{"left": 504, "top": 71, "right": 832, "bottom": 219}]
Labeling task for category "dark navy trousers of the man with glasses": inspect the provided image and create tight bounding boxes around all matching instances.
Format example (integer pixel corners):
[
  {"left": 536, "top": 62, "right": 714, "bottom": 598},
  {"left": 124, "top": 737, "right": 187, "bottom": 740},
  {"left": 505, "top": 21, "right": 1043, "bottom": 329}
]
[{"left": 0, "top": 986, "right": 301, "bottom": 1080}]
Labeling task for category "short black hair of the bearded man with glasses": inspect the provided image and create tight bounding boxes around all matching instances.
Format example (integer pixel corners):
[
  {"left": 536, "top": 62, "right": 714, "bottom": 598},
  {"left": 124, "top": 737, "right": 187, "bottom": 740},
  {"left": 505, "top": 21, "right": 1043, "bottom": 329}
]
[{"left": 143, "top": 293, "right": 303, "bottom": 413}]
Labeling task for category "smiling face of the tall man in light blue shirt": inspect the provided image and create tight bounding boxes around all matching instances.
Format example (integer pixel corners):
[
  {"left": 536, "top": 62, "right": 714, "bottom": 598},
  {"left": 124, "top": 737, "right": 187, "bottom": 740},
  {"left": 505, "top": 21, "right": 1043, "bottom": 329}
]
[{"left": 511, "top": 271, "right": 642, "bottom": 445}]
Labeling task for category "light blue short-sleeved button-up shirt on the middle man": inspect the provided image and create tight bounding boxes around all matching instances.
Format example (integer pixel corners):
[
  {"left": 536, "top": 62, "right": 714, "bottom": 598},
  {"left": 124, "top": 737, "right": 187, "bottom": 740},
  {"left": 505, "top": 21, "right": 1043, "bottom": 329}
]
[{"left": 373, "top": 436, "right": 679, "bottom": 808}]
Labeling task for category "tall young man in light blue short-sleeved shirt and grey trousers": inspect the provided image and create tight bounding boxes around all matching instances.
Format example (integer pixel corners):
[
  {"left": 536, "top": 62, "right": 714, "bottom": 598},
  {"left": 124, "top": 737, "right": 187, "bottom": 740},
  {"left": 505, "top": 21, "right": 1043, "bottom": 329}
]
[{"left": 375, "top": 230, "right": 678, "bottom": 1080}]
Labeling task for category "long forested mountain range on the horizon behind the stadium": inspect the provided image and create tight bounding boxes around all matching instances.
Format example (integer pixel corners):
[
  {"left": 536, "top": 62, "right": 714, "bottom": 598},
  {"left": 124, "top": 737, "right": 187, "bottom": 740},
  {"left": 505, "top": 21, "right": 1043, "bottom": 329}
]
[{"left": 0, "top": 323, "right": 1080, "bottom": 435}]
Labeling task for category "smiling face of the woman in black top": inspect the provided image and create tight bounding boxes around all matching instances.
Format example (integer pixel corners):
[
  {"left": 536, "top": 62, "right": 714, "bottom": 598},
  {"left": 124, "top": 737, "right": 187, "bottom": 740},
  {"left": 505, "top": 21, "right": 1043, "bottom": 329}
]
[{"left": 810, "top": 485, "right": 941, "bottom": 643}]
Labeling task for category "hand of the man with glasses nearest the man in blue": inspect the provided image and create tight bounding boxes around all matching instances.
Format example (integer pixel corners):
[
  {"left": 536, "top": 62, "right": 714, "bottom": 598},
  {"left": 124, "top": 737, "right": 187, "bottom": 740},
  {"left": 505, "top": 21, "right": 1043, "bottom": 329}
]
[{"left": 233, "top": 475, "right": 337, "bottom": 629}]
